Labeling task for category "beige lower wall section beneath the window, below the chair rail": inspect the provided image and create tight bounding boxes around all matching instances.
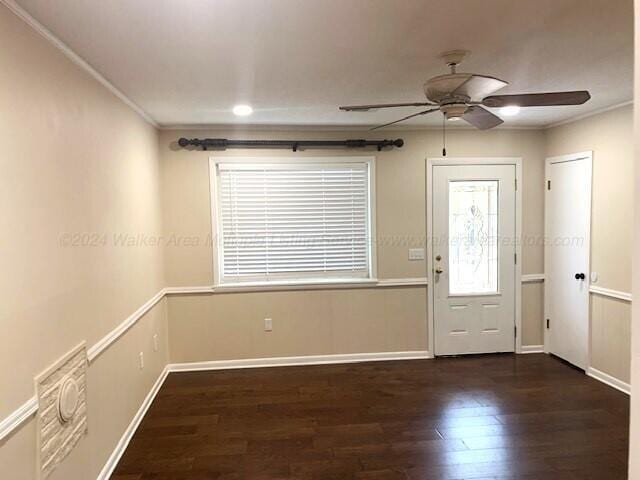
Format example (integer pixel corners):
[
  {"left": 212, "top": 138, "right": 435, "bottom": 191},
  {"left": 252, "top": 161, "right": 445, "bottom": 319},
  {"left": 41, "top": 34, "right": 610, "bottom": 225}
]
[{"left": 169, "top": 287, "right": 427, "bottom": 362}]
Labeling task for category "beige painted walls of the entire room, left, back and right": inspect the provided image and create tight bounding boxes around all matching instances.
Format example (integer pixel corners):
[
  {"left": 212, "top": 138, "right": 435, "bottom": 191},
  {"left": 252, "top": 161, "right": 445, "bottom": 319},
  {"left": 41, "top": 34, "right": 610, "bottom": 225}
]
[{"left": 0, "top": 1, "right": 640, "bottom": 480}]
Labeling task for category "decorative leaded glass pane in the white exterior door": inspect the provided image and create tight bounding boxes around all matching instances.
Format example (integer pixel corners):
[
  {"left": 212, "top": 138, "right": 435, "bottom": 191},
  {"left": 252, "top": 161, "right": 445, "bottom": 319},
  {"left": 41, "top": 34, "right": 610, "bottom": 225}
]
[{"left": 449, "top": 180, "right": 498, "bottom": 295}]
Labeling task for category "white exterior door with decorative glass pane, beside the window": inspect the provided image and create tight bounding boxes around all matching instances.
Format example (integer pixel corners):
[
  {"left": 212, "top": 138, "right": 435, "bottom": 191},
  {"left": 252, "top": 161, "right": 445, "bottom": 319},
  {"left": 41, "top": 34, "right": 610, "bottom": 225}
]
[{"left": 432, "top": 165, "right": 516, "bottom": 355}]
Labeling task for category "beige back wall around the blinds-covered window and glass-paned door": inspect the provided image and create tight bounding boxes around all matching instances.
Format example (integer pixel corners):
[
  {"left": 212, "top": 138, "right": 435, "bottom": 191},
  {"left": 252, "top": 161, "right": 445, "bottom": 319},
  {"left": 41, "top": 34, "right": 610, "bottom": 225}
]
[{"left": 160, "top": 125, "right": 544, "bottom": 361}]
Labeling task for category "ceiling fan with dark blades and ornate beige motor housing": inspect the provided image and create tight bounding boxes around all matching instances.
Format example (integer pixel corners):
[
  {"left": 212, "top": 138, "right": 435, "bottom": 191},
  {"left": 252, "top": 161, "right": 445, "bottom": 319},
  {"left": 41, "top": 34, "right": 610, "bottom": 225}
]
[{"left": 339, "top": 50, "right": 591, "bottom": 130}]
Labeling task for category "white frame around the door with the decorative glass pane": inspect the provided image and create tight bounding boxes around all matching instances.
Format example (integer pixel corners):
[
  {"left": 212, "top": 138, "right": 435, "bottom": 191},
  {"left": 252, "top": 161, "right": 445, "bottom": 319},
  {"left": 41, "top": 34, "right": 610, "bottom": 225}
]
[{"left": 425, "top": 157, "right": 523, "bottom": 355}]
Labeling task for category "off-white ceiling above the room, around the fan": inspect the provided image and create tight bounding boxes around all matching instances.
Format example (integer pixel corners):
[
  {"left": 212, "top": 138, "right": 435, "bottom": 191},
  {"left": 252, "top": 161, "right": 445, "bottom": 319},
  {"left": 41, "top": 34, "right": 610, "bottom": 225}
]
[{"left": 18, "top": 0, "right": 633, "bottom": 126}]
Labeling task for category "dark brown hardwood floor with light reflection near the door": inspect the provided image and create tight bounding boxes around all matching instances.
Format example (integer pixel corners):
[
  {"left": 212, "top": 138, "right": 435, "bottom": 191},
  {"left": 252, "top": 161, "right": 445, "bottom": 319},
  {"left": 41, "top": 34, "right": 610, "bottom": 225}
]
[{"left": 111, "top": 354, "right": 629, "bottom": 480}]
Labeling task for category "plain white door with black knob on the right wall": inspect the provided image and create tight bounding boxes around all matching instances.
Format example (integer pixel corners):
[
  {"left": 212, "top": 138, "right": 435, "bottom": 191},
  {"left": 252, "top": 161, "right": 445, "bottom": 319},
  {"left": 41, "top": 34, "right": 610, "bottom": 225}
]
[{"left": 544, "top": 153, "right": 591, "bottom": 370}]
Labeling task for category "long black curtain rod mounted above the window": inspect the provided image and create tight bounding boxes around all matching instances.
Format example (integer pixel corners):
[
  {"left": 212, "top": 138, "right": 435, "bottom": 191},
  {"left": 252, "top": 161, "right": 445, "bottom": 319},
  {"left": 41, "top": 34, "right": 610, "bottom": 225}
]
[{"left": 178, "top": 137, "right": 404, "bottom": 152}]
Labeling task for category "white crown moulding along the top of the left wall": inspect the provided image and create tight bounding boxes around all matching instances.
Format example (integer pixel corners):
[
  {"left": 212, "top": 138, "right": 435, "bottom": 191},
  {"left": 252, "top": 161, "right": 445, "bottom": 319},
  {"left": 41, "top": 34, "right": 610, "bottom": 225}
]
[{"left": 0, "top": 0, "right": 159, "bottom": 128}]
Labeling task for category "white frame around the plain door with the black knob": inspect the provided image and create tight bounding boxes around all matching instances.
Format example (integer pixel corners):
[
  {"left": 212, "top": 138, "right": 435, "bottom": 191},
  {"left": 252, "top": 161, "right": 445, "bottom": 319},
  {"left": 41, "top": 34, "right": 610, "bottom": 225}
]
[{"left": 542, "top": 150, "right": 593, "bottom": 362}]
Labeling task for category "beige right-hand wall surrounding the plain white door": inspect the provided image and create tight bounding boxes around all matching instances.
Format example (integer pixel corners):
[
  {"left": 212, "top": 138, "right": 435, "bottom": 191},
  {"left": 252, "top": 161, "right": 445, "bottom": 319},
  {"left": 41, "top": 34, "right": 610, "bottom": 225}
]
[{"left": 546, "top": 105, "right": 633, "bottom": 382}]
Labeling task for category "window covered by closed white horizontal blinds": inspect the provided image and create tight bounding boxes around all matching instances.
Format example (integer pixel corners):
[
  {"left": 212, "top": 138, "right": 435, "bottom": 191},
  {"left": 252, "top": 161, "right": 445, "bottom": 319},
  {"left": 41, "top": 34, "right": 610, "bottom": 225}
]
[{"left": 211, "top": 158, "right": 373, "bottom": 284}]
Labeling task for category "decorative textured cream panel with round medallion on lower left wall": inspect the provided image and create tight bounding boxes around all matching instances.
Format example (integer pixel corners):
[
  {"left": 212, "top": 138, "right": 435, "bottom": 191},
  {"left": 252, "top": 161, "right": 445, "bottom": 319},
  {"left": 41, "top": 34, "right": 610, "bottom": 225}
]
[{"left": 36, "top": 342, "right": 87, "bottom": 479}]
